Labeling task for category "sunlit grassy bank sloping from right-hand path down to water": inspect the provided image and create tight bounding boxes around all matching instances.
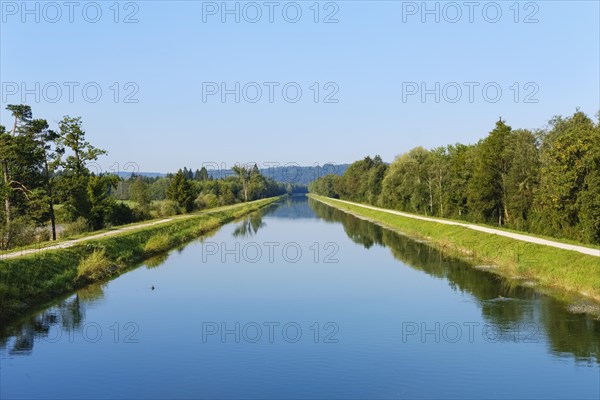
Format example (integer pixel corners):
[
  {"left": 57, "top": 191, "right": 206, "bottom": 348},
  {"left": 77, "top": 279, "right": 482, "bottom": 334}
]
[{"left": 310, "top": 195, "right": 600, "bottom": 302}]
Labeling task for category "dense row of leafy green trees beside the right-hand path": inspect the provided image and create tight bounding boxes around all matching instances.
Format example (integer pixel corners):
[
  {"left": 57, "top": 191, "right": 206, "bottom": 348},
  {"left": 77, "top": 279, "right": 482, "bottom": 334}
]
[{"left": 309, "top": 111, "right": 600, "bottom": 244}]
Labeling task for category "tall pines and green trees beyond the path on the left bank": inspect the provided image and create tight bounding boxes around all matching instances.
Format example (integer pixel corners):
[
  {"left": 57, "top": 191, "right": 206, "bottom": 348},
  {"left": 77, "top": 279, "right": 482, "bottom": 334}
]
[{"left": 0, "top": 104, "right": 286, "bottom": 249}]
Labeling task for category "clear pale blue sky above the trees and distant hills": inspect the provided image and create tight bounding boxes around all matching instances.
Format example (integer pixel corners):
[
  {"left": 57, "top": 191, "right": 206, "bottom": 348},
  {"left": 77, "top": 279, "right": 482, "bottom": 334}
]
[{"left": 0, "top": 1, "right": 600, "bottom": 171}]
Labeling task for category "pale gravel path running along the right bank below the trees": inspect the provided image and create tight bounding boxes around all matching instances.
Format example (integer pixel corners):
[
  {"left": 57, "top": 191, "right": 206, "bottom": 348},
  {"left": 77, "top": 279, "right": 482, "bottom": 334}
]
[{"left": 315, "top": 198, "right": 600, "bottom": 257}]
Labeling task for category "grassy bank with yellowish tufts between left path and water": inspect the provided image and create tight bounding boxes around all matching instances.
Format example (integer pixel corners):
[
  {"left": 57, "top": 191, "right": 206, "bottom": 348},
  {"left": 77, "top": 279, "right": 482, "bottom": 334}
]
[{"left": 0, "top": 197, "right": 280, "bottom": 321}]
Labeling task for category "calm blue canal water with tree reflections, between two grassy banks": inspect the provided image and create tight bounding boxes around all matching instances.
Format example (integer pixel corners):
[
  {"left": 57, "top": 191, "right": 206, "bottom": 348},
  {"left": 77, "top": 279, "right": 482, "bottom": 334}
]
[{"left": 0, "top": 197, "right": 600, "bottom": 400}]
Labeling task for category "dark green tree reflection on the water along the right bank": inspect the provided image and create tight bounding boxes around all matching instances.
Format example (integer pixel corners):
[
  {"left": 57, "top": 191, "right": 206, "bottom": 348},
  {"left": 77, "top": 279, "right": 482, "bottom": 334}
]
[{"left": 308, "top": 199, "right": 600, "bottom": 363}]
